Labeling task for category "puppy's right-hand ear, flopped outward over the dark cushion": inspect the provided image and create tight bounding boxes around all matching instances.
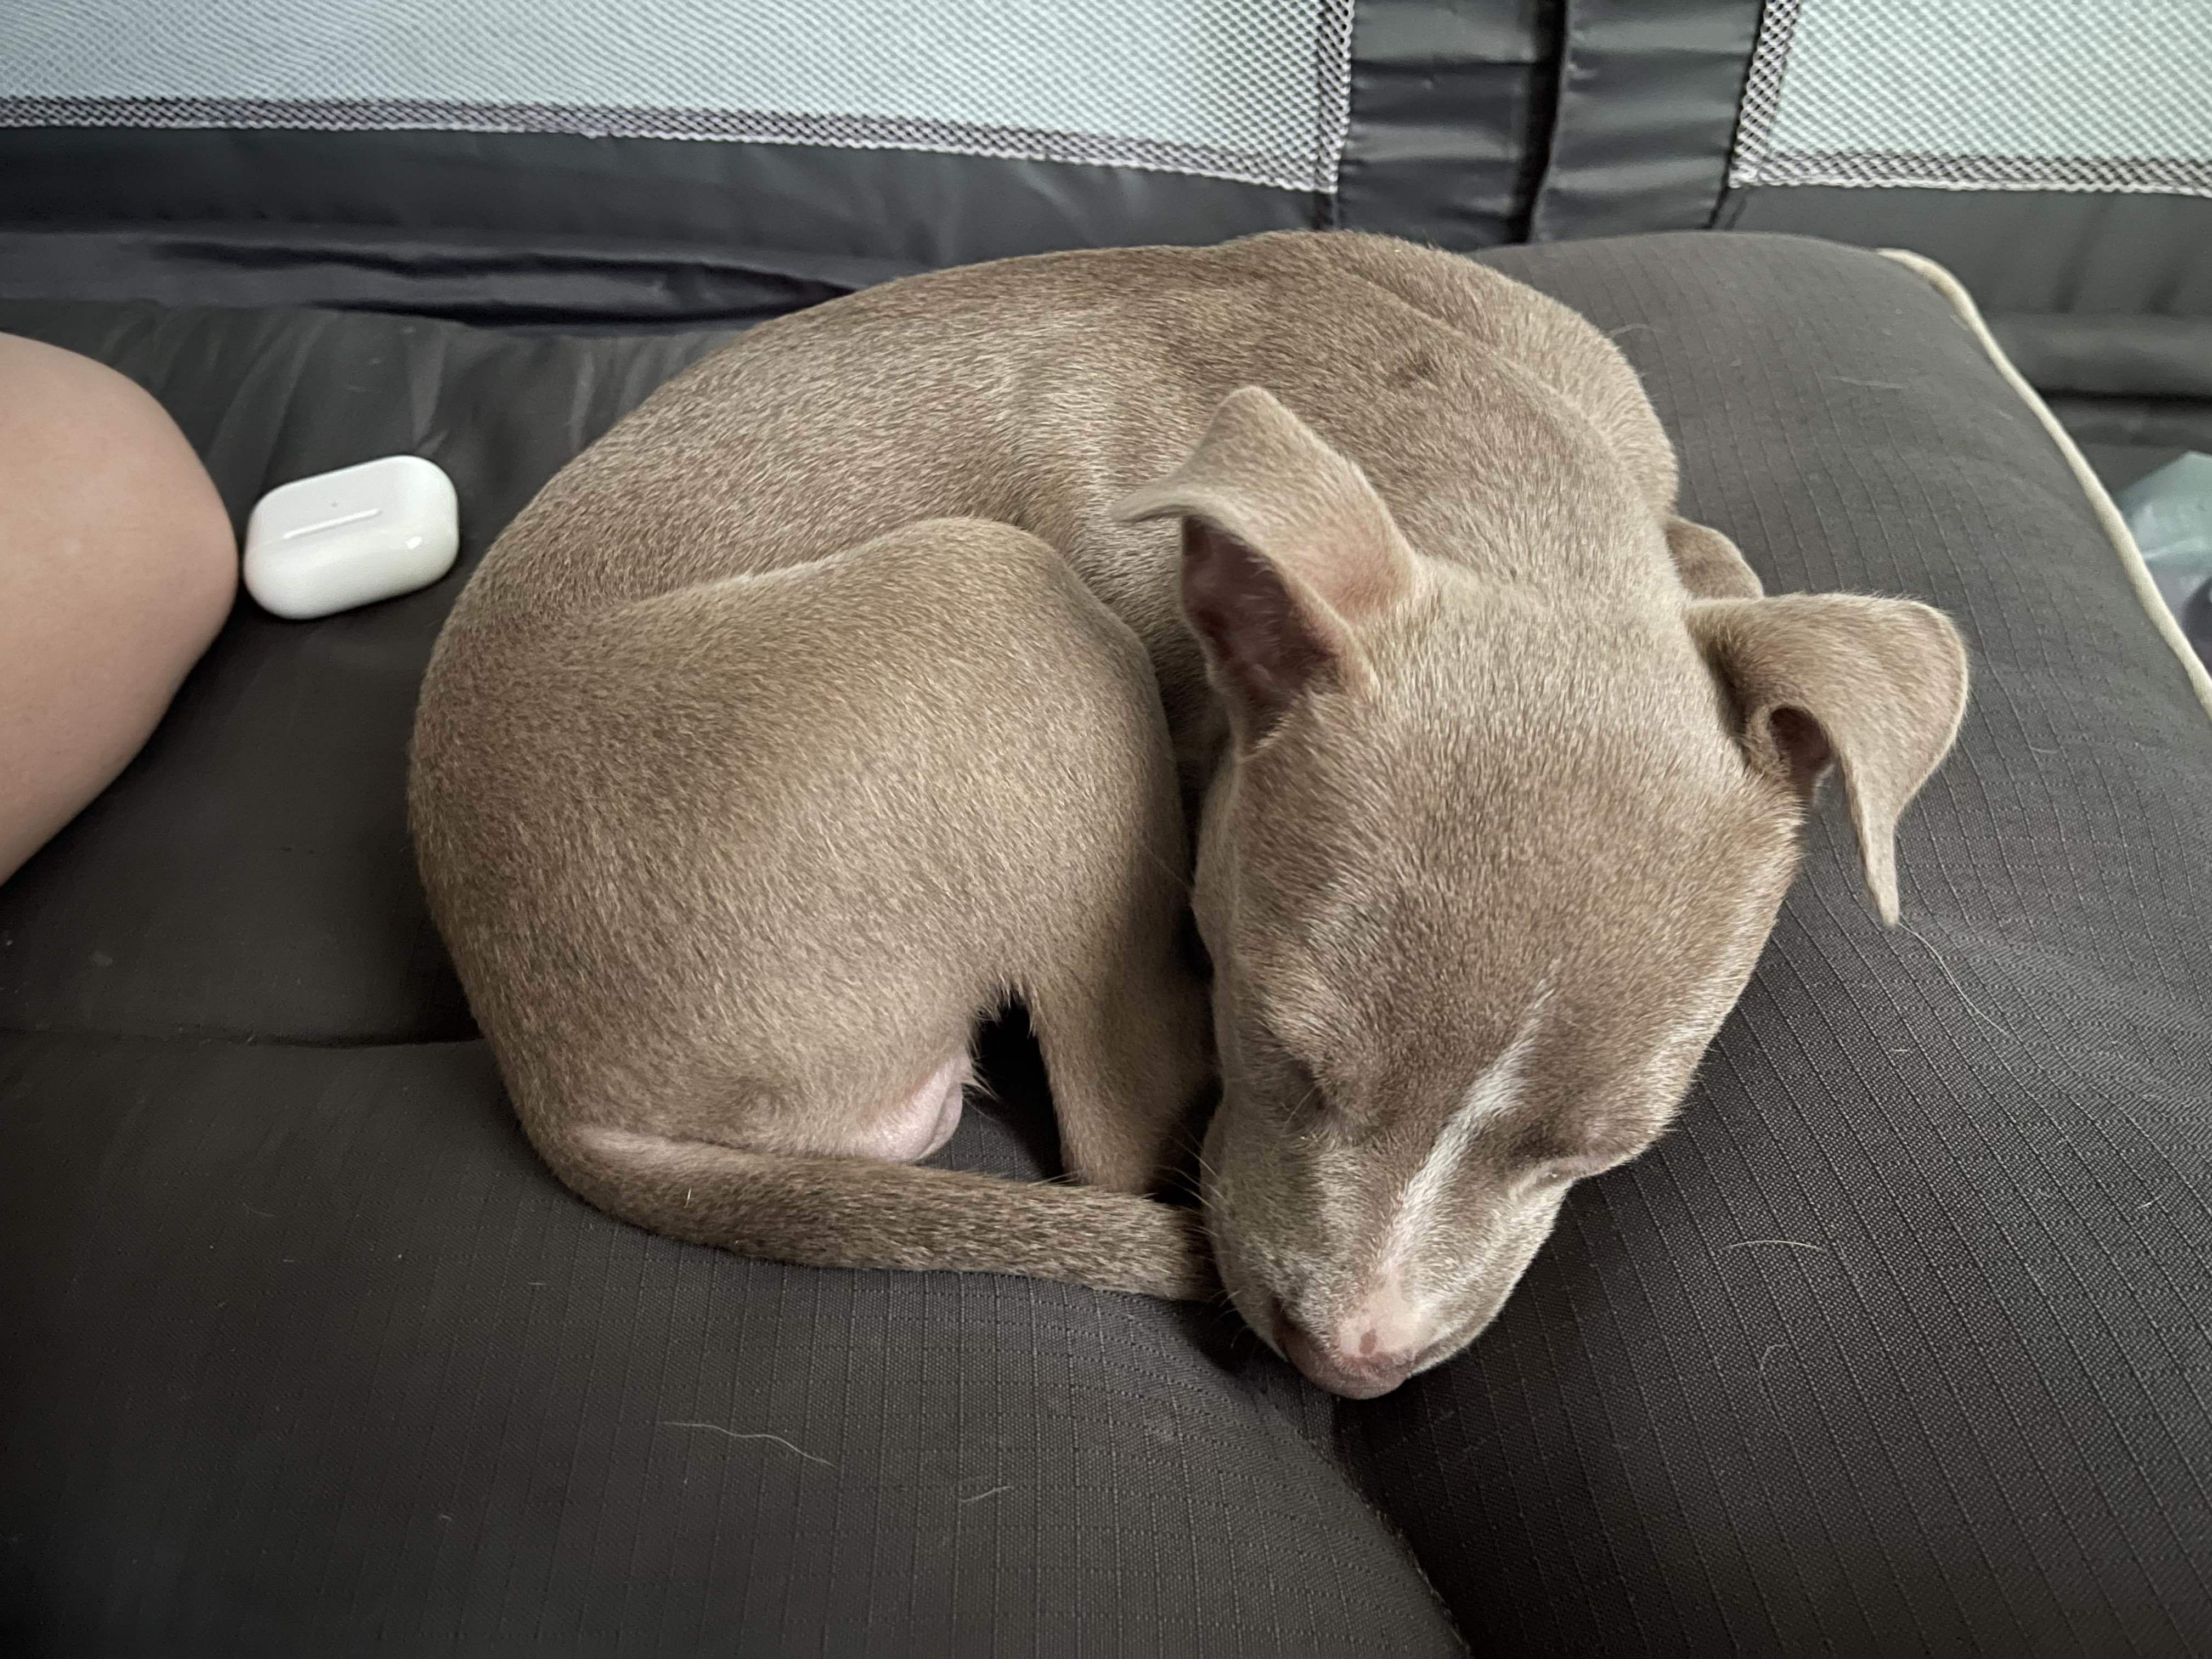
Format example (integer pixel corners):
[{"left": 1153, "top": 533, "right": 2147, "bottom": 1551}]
[{"left": 1688, "top": 593, "right": 1966, "bottom": 922}]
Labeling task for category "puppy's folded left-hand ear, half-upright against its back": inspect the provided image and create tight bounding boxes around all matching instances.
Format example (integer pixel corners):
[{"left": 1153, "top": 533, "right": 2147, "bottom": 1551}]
[{"left": 1115, "top": 387, "right": 1413, "bottom": 746}]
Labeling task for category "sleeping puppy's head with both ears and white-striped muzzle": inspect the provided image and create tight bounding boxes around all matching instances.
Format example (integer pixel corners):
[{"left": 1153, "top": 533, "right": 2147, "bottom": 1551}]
[{"left": 1124, "top": 390, "right": 1966, "bottom": 1398}]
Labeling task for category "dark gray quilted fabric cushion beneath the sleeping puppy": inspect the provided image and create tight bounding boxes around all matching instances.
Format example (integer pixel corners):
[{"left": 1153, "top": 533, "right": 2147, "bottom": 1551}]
[{"left": 0, "top": 234, "right": 2212, "bottom": 1655}]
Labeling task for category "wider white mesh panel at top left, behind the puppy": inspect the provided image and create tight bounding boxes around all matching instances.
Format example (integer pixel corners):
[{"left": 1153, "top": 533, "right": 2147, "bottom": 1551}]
[{"left": 0, "top": 0, "right": 1352, "bottom": 190}]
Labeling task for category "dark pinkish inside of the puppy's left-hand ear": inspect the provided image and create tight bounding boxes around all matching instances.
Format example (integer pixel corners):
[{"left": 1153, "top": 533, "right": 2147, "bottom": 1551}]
[{"left": 1183, "top": 517, "right": 1352, "bottom": 741}]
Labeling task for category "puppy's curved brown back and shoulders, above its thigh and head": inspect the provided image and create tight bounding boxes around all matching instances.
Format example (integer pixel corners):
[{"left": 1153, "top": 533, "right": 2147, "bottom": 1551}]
[{"left": 449, "top": 232, "right": 1674, "bottom": 776}]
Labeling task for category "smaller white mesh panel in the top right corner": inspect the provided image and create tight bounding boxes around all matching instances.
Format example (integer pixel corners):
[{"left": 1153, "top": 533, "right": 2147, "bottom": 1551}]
[{"left": 1730, "top": 0, "right": 2212, "bottom": 195}]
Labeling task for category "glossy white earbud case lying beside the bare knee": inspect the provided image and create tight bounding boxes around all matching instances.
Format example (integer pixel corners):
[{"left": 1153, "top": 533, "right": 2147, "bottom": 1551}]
[{"left": 246, "top": 456, "right": 460, "bottom": 619}]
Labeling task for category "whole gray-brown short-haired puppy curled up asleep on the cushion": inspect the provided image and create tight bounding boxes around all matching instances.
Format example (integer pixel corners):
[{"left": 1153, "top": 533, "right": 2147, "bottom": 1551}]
[{"left": 414, "top": 232, "right": 1966, "bottom": 1396}]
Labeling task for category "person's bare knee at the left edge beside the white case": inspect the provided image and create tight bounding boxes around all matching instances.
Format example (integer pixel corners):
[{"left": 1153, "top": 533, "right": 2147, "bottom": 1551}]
[{"left": 0, "top": 334, "right": 239, "bottom": 881}]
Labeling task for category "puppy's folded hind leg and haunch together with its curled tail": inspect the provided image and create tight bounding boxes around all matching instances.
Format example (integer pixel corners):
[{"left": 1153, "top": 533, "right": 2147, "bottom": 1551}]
[{"left": 416, "top": 520, "right": 1212, "bottom": 1296}]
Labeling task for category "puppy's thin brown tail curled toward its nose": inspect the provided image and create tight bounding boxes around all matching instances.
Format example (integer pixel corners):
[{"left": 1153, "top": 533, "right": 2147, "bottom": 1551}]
[{"left": 531, "top": 1124, "right": 1217, "bottom": 1301}]
